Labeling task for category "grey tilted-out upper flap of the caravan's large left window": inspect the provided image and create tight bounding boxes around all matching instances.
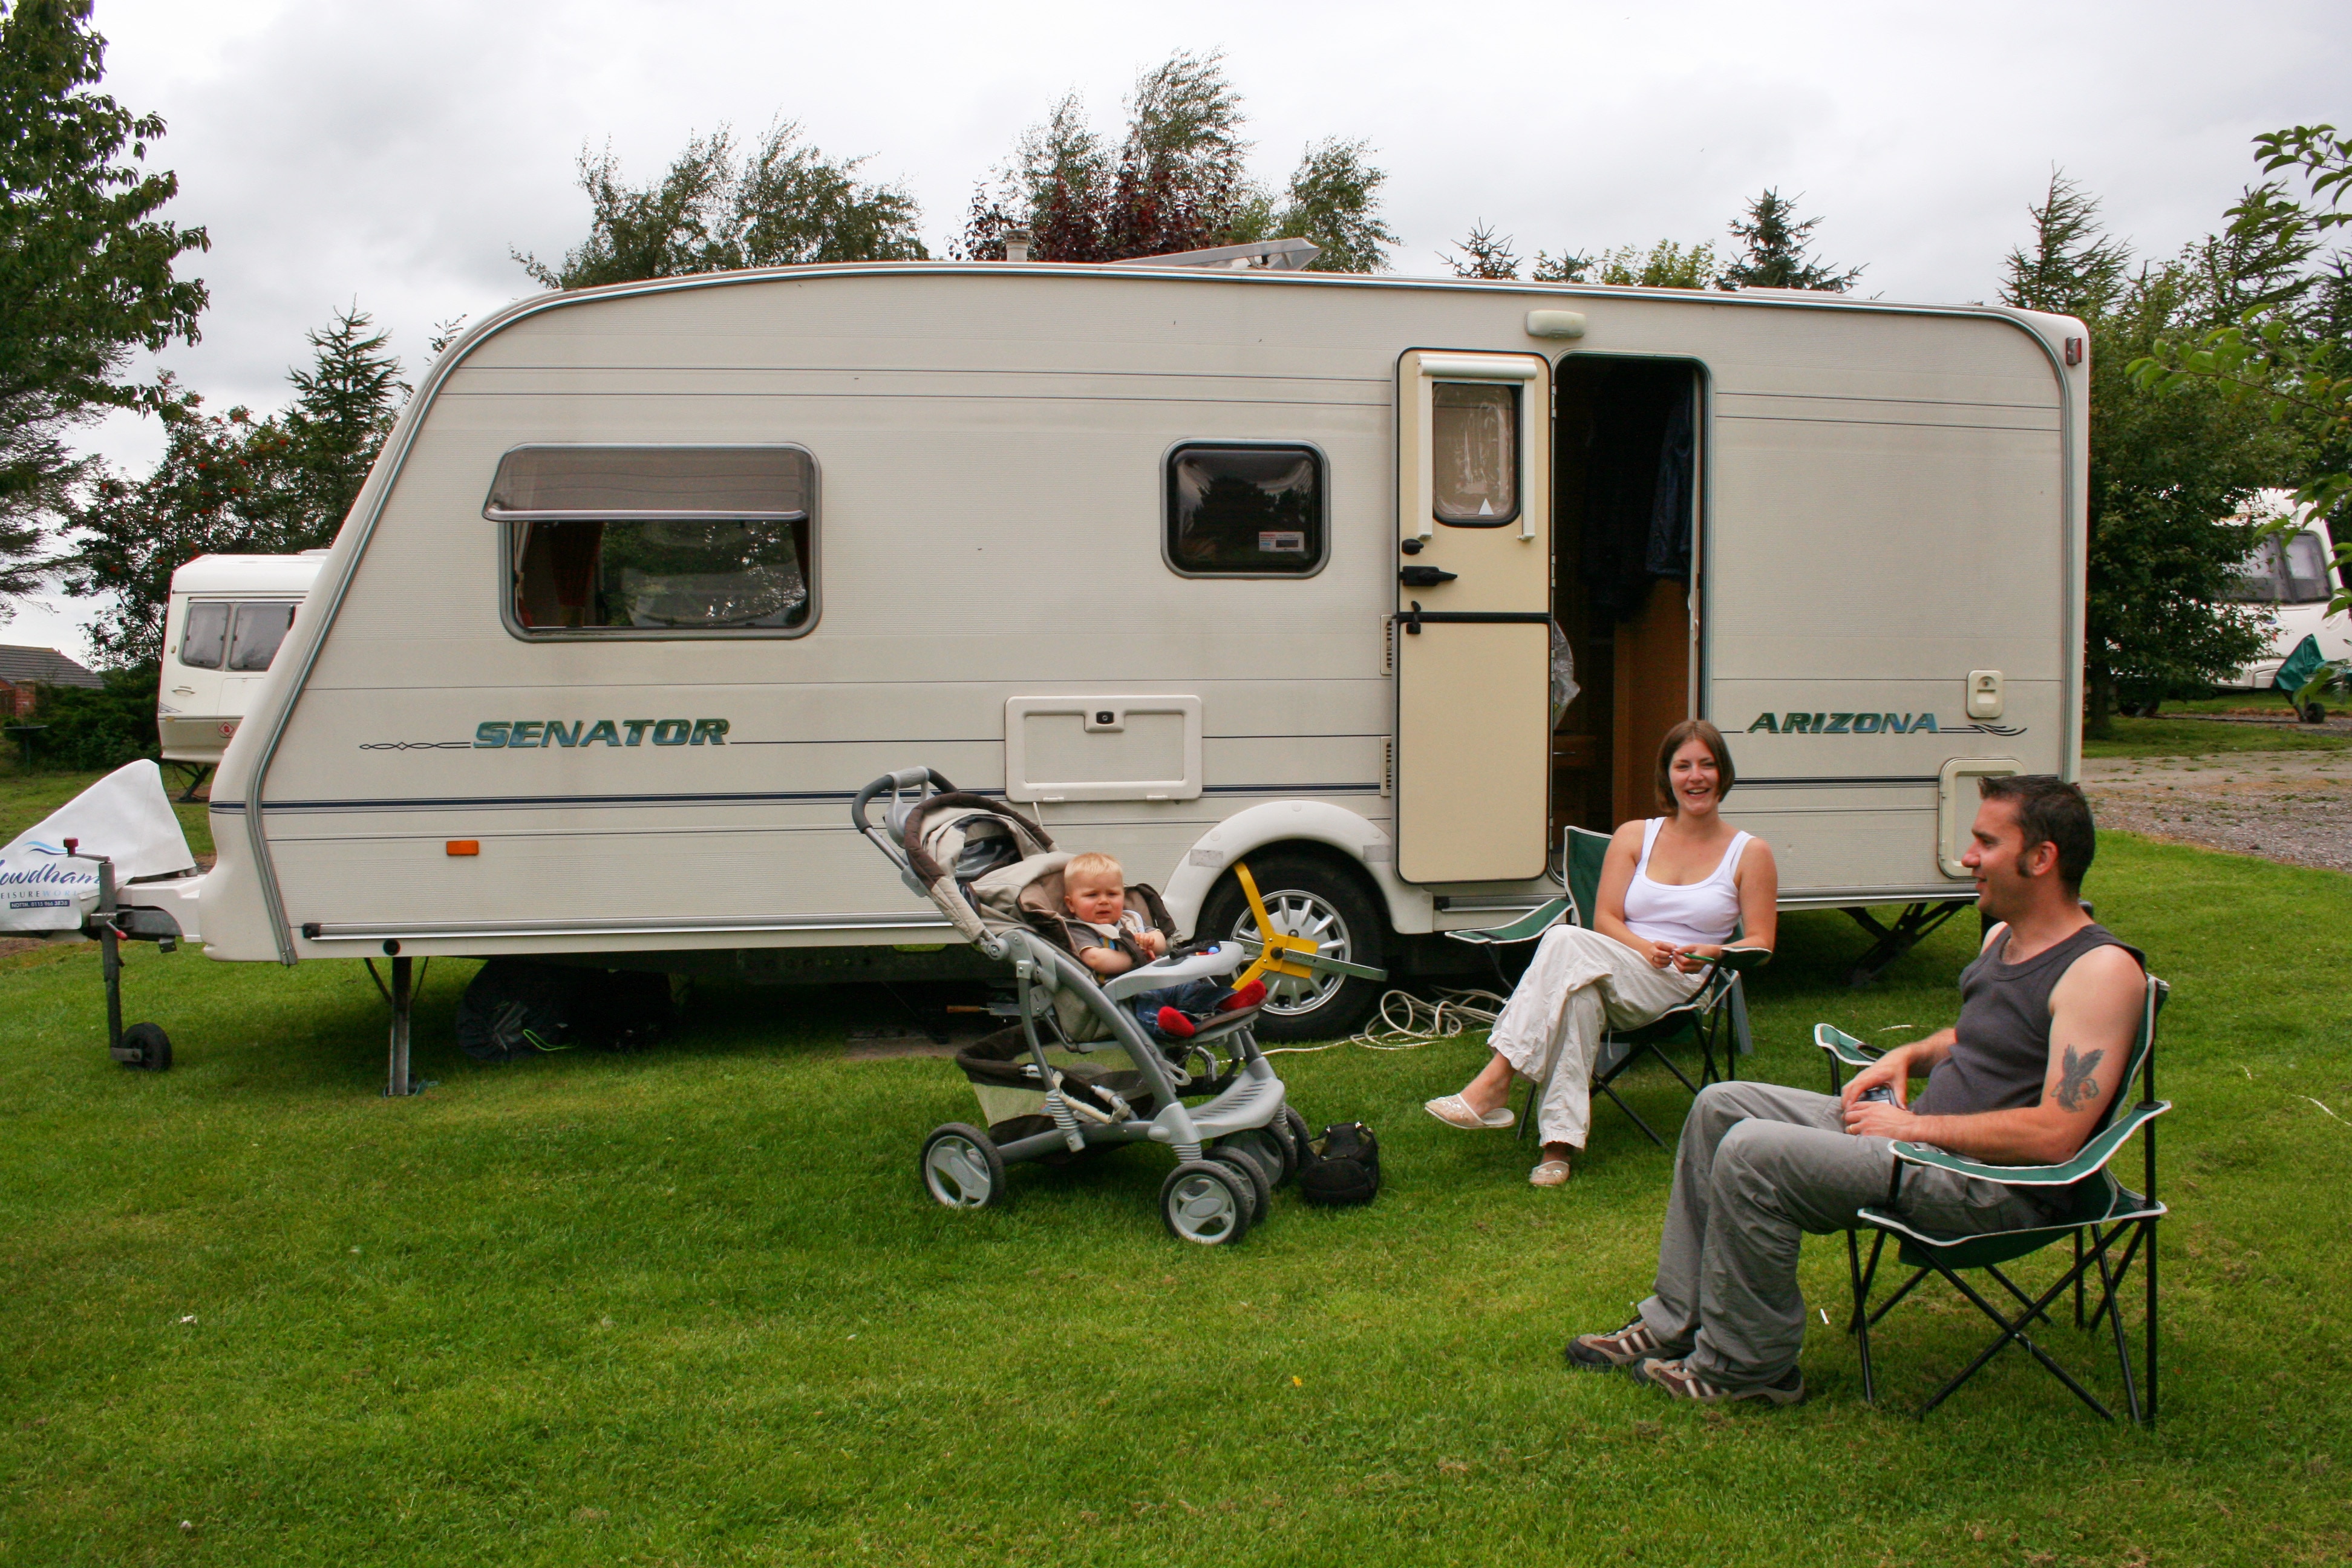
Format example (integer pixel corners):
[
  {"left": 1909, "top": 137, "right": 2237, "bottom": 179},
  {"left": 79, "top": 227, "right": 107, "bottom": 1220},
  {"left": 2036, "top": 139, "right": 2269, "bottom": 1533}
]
[{"left": 482, "top": 446, "right": 809, "bottom": 522}]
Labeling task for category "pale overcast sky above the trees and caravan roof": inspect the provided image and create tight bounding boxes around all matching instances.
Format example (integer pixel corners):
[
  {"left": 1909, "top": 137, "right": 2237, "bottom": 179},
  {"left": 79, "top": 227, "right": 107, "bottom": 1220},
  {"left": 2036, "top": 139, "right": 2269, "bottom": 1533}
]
[{"left": 0, "top": 0, "right": 2352, "bottom": 653}]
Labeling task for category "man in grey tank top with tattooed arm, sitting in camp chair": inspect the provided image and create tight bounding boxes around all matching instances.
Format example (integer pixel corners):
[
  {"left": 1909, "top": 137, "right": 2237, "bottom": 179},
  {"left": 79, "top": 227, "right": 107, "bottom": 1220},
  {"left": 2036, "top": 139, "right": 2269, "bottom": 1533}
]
[{"left": 1566, "top": 776, "right": 2145, "bottom": 1403}]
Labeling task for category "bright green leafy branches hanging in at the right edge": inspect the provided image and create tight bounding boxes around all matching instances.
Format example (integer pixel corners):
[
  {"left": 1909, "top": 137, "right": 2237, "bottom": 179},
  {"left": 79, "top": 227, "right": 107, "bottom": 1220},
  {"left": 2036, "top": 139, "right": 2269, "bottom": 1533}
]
[{"left": 2129, "top": 125, "right": 2352, "bottom": 613}]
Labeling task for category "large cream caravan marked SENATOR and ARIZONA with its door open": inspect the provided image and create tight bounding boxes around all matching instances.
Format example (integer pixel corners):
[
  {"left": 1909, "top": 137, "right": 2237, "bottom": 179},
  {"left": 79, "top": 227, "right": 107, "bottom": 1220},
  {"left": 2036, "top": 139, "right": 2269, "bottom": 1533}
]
[{"left": 127, "top": 263, "right": 2086, "bottom": 1034}]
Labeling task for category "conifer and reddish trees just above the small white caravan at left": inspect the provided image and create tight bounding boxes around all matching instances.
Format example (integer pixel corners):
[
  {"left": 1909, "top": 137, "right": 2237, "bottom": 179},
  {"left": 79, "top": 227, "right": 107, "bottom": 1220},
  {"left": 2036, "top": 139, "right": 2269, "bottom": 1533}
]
[{"left": 61, "top": 308, "right": 407, "bottom": 668}]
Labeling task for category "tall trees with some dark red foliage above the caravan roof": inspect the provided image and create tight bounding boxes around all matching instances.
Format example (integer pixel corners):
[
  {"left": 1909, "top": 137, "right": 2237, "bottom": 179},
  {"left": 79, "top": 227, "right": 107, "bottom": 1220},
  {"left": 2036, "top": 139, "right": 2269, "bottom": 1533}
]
[{"left": 955, "top": 51, "right": 1397, "bottom": 273}]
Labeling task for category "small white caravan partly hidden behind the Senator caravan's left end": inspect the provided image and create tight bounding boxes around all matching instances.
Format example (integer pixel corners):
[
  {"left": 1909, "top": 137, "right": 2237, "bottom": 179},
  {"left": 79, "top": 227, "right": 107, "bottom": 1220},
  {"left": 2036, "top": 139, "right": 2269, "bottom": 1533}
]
[{"left": 155, "top": 550, "right": 327, "bottom": 766}]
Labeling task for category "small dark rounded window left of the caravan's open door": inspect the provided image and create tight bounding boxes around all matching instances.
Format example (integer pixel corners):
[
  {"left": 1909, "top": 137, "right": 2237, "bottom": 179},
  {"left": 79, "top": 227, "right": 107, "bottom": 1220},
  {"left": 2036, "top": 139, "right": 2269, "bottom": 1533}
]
[{"left": 1165, "top": 444, "right": 1324, "bottom": 576}]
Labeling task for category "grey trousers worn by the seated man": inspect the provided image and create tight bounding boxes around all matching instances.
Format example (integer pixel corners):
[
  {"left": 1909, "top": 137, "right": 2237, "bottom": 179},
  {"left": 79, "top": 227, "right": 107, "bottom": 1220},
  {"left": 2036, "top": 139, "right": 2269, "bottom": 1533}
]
[{"left": 1642, "top": 1082, "right": 2047, "bottom": 1387}]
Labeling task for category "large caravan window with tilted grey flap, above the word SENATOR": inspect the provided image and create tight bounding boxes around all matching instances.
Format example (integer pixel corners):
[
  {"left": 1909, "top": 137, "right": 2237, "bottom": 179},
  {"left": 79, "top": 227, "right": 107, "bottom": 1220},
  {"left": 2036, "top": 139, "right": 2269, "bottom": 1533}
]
[{"left": 482, "top": 446, "right": 816, "bottom": 637}]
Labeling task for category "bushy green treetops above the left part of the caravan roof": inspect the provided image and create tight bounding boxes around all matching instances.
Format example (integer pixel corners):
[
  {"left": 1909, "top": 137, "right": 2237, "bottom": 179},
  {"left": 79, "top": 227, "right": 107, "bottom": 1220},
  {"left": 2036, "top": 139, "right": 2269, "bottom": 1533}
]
[{"left": 508, "top": 120, "right": 929, "bottom": 289}]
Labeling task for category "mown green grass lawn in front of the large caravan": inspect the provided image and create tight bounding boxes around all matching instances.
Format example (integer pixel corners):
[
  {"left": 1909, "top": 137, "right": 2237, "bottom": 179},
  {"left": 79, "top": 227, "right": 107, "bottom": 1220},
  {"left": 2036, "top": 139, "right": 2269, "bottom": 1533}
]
[{"left": 0, "top": 835, "right": 2352, "bottom": 1568}]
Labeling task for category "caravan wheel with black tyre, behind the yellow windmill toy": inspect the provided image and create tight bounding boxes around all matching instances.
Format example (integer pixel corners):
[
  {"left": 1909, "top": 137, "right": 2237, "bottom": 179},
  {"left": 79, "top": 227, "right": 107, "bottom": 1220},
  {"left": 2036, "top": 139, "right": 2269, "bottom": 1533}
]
[{"left": 1200, "top": 856, "right": 1385, "bottom": 1042}]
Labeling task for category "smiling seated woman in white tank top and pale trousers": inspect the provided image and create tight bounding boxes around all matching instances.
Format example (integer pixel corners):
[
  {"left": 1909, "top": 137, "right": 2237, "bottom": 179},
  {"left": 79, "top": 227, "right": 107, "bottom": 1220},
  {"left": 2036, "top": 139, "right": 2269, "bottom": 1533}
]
[{"left": 1428, "top": 719, "right": 1780, "bottom": 1187}]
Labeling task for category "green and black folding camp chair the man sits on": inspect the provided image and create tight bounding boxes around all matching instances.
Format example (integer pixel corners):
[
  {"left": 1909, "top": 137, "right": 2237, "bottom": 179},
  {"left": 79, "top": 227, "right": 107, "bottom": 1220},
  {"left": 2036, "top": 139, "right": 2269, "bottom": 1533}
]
[{"left": 1814, "top": 976, "right": 2171, "bottom": 1427}]
